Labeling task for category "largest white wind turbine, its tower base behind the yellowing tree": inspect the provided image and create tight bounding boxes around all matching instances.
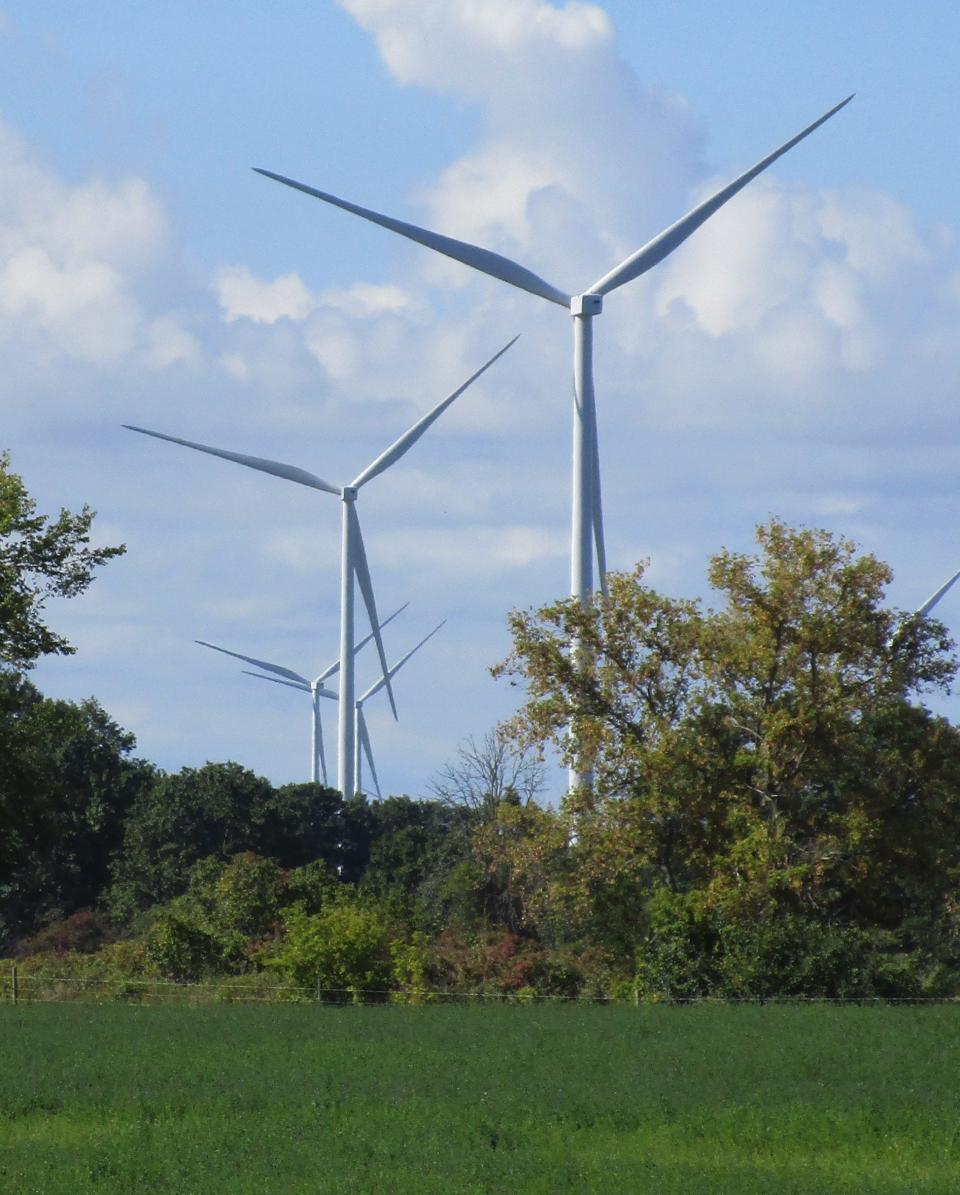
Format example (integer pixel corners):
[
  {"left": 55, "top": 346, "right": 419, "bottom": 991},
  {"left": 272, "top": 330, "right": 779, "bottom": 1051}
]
[{"left": 255, "top": 96, "right": 854, "bottom": 786}]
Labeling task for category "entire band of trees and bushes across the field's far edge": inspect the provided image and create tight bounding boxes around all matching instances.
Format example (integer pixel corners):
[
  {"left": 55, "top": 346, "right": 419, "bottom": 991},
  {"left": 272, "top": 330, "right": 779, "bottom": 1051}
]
[{"left": 0, "top": 456, "right": 960, "bottom": 999}]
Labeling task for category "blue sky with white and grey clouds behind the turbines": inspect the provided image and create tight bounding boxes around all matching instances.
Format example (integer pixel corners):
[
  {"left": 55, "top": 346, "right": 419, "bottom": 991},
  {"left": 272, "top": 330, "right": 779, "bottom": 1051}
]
[{"left": 0, "top": 0, "right": 960, "bottom": 793}]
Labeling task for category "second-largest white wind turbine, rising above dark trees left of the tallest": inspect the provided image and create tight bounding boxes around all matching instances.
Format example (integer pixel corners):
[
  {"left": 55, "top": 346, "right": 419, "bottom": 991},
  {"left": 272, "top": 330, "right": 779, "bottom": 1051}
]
[{"left": 123, "top": 337, "right": 518, "bottom": 797}]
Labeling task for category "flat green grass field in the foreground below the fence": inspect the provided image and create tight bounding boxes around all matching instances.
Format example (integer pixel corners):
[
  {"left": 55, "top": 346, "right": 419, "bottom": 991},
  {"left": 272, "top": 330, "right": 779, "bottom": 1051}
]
[{"left": 0, "top": 1005, "right": 960, "bottom": 1195}]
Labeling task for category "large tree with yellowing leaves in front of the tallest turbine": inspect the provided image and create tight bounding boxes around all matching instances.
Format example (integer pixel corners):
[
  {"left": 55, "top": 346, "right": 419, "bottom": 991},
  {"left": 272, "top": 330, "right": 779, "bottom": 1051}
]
[{"left": 501, "top": 520, "right": 960, "bottom": 994}]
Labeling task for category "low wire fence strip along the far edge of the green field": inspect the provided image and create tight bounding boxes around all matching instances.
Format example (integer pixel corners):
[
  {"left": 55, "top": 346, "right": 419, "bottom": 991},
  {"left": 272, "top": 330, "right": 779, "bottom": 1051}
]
[{"left": 7, "top": 963, "right": 960, "bottom": 1007}]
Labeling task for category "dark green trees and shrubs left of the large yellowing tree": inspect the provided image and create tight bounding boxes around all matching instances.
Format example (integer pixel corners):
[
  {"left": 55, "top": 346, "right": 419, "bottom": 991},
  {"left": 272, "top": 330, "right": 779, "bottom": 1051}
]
[{"left": 0, "top": 672, "right": 607, "bottom": 998}]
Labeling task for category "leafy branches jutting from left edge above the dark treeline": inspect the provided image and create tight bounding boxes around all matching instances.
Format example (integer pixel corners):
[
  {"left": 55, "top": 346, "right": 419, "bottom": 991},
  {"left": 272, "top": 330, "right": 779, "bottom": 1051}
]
[{"left": 0, "top": 453, "right": 126, "bottom": 668}]
